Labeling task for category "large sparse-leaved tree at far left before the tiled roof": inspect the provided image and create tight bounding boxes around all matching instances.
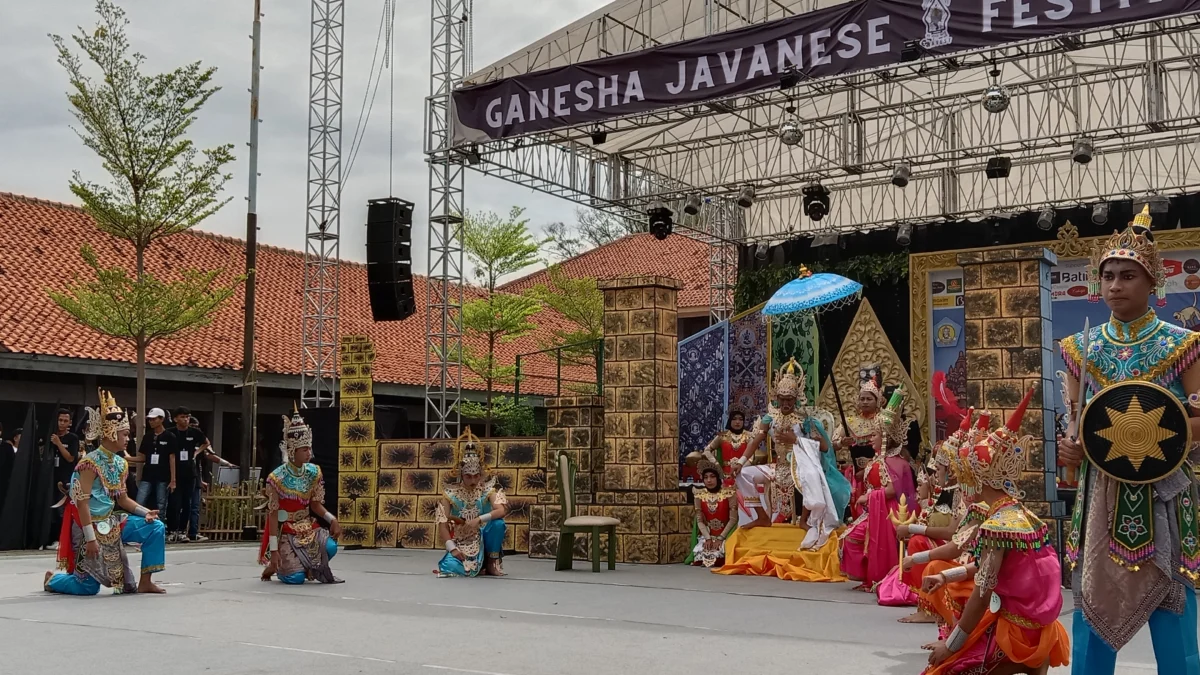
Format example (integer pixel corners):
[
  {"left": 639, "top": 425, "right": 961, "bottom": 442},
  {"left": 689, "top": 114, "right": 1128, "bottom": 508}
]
[{"left": 50, "top": 0, "right": 233, "bottom": 436}]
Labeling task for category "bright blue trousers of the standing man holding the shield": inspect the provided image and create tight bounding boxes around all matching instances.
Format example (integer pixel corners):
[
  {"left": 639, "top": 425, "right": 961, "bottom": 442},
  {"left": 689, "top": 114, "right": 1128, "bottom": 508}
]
[{"left": 1070, "top": 587, "right": 1200, "bottom": 675}]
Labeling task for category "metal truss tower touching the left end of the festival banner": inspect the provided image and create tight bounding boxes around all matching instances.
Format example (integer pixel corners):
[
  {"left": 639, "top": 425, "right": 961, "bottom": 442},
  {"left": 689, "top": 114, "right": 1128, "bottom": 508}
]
[{"left": 425, "top": 0, "right": 472, "bottom": 438}]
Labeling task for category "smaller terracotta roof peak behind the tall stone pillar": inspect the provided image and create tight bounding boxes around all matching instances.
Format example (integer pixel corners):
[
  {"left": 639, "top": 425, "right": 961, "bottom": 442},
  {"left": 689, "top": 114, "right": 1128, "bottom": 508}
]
[{"left": 500, "top": 233, "right": 733, "bottom": 309}]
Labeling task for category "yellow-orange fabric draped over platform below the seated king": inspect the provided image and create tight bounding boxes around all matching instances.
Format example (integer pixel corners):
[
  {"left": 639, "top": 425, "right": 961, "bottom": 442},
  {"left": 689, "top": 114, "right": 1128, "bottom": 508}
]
[{"left": 713, "top": 524, "right": 846, "bottom": 581}]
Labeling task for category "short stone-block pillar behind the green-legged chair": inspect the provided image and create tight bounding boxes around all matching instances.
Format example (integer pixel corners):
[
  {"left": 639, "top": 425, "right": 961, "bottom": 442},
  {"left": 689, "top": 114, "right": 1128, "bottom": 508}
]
[{"left": 530, "top": 396, "right": 604, "bottom": 560}]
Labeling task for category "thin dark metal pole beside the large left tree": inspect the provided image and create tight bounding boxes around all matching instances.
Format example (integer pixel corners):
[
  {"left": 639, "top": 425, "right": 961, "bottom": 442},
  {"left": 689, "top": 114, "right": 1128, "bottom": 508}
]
[{"left": 239, "top": 0, "right": 263, "bottom": 478}]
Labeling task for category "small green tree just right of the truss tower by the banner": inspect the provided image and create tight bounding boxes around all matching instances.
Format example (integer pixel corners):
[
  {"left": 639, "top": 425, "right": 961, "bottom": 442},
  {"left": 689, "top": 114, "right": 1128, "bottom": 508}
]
[{"left": 460, "top": 207, "right": 541, "bottom": 436}]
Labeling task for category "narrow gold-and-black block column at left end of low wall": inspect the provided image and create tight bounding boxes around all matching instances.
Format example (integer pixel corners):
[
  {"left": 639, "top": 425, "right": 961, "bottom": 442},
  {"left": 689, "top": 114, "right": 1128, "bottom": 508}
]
[{"left": 337, "top": 335, "right": 376, "bottom": 548}]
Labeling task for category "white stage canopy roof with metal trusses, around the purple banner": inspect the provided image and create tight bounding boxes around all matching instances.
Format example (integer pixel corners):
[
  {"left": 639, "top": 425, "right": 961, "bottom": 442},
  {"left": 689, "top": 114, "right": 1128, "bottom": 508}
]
[{"left": 451, "top": 0, "right": 1200, "bottom": 247}]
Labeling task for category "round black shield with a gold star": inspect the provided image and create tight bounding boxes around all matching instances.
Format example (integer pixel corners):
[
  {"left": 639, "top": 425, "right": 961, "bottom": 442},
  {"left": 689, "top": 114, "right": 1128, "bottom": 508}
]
[{"left": 1080, "top": 382, "right": 1192, "bottom": 483}]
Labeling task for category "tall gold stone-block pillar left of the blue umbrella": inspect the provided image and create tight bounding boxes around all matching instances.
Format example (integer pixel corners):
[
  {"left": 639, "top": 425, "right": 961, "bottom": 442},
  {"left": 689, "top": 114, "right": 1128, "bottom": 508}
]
[{"left": 595, "top": 276, "right": 691, "bottom": 563}]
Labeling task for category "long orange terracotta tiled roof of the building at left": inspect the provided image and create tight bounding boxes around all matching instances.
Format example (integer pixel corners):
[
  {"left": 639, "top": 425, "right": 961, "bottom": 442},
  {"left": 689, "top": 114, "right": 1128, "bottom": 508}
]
[{"left": 0, "top": 192, "right": 585, "bottom": 393}]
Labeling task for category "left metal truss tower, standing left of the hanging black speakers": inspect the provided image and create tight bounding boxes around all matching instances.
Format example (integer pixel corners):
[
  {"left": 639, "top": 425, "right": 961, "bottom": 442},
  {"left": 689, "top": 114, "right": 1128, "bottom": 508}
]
[{"left": 300, "top": 0, "right": 344, "bottom": 407}]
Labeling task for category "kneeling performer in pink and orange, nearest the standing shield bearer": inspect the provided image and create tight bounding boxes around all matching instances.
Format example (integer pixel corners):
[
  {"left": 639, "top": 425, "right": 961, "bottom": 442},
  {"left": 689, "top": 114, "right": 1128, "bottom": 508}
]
[{"left": 925, "top": 388, "right": 1070, "bottom": 675}]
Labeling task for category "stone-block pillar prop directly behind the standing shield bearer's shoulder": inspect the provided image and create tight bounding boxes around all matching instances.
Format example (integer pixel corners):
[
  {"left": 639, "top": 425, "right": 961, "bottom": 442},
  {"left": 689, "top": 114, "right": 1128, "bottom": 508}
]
[{"left": 958, "top": 246, "right": 1066, "bottom": 514}]
